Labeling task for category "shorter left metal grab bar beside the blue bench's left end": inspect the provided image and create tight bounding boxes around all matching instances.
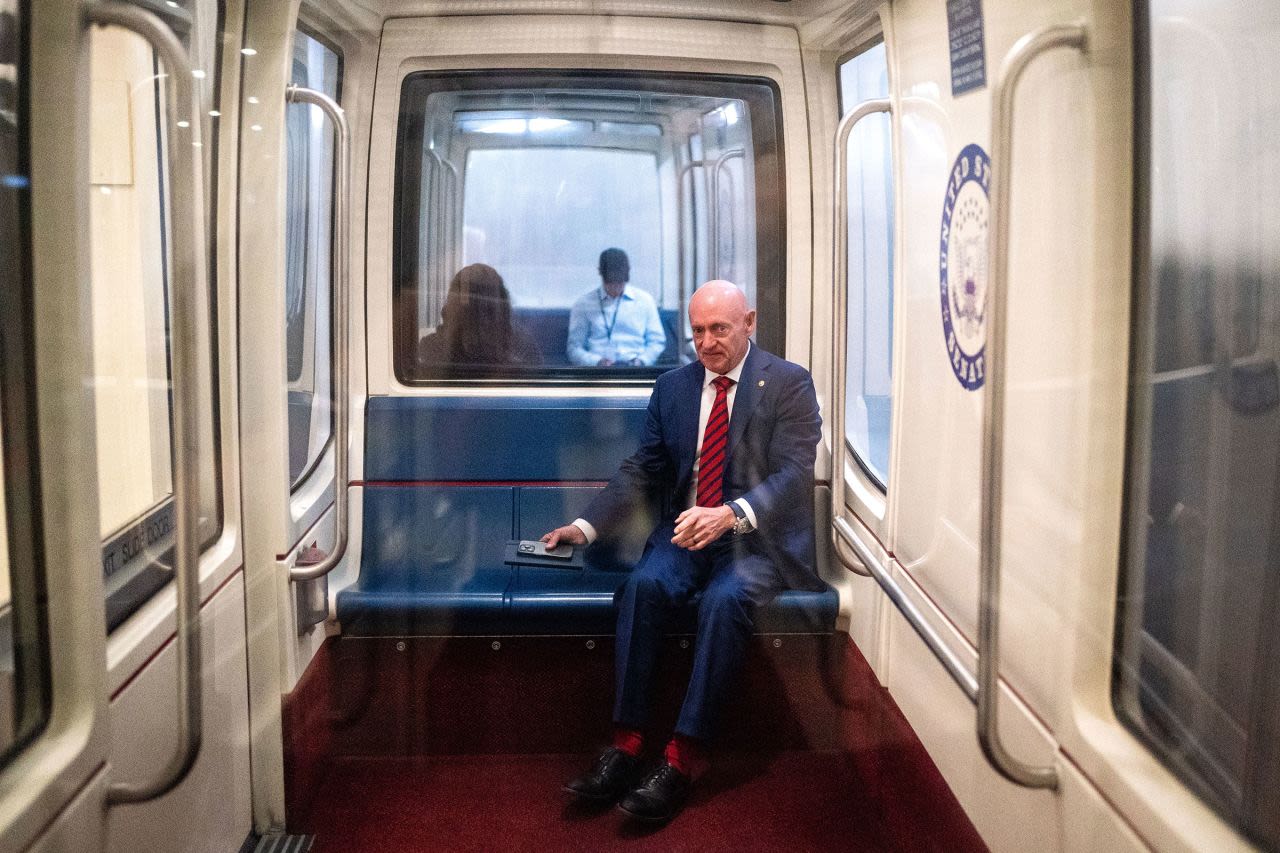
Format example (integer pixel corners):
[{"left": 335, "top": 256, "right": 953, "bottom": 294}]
[{"left": 284, "top": 86, "right": 351, "bottom": 580}]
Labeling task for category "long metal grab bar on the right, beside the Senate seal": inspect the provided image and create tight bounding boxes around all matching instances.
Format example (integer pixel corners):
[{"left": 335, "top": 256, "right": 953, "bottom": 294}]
[{"left": 978, "top": 23, "right": 1088, "bottom": 789}]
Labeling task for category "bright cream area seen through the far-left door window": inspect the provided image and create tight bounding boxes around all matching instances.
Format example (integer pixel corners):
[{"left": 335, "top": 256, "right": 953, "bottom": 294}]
[{"left": 90, "top": 27, "right": 173, "bottom": 537}]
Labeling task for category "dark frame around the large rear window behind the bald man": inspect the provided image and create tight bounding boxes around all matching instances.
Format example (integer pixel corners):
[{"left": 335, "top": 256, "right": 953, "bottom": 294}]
[{"left": 390, "top": 68, "right": 787, "bottom": 388}]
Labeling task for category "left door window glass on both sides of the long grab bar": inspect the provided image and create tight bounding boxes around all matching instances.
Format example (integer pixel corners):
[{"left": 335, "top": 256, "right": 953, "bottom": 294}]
[{"left": 90, "top": 0, "right": 223, "bottom": 629}]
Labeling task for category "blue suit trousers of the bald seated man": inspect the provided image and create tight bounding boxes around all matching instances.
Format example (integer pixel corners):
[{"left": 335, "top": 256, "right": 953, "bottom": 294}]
[{"left": 613, "top": 523, "right": 786, "bottom": 740}]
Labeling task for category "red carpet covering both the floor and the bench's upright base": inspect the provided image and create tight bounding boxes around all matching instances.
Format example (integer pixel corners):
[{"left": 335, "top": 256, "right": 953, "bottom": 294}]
[{"left": 284, "top": 635, "right": 986, "bottom": 853}]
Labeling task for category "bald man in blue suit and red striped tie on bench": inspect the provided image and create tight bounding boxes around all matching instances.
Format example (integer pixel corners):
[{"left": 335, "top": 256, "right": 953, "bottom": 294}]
[{"left": 543, "top": 280, "right": 824, "bottom": 821}]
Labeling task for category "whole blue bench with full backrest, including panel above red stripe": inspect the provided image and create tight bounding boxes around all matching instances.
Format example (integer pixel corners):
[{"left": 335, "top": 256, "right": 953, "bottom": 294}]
[{"left": 338, "top": 396, "right": 838, "bottom": 637}]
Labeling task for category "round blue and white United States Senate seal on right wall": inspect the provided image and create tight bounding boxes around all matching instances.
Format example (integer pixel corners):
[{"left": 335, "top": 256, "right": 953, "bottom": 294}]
[{"left": 938, "top": 145, "right": 991, "bottom": 391}]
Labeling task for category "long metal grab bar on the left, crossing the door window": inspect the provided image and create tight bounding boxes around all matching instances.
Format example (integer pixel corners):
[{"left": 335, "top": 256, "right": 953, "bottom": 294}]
[{"left": 83, "top": 3, "right": 206, "bottom": 807}]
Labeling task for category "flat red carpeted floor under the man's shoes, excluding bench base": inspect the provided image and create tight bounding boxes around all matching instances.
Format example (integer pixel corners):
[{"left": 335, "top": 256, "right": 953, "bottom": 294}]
[{"left": 305, "top": 752, "right": 904, "bottom": 853}]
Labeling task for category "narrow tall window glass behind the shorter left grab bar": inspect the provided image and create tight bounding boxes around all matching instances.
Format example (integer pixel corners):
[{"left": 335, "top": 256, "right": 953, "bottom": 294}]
[{"left": 284, "top": 31, "right": 342, "bottom": 487}]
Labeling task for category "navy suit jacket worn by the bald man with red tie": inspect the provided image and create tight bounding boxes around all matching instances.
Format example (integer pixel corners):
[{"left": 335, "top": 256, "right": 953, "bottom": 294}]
[{"left": 582, "top": 345, "right": 826, "bottom": 589}]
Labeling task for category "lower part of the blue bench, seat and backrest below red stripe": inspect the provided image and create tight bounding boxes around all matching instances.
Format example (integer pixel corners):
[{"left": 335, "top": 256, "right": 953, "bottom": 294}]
[{"left": 338, "top": 484, "right": 838, "bottom": 637}]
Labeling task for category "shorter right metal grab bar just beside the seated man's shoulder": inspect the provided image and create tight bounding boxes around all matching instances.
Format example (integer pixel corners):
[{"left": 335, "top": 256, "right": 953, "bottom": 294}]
[{"left": 829, "top": 99, "right": 893, "bottom": 578}]
